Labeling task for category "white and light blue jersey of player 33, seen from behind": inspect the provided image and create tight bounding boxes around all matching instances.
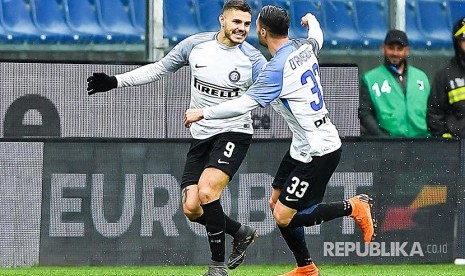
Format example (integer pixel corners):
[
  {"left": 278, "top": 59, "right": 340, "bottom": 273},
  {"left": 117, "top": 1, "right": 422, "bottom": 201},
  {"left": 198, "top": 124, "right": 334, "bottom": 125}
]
[{"left": 247, "top": 39, "right": 341, "bottom": 162}]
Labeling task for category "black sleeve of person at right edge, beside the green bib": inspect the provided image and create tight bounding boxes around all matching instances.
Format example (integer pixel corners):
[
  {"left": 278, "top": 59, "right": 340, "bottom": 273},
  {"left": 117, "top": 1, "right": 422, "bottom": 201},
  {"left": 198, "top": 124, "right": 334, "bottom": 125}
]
[{"left": 426, "top": 69, "right": 448, "bottom": 137}]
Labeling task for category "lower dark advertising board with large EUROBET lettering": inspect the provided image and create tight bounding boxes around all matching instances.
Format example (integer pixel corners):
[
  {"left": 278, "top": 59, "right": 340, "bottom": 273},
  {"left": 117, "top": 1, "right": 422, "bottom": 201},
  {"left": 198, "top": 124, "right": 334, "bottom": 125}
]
[{"left": 0, "top": 138, "right": 458, "bottom": 266}]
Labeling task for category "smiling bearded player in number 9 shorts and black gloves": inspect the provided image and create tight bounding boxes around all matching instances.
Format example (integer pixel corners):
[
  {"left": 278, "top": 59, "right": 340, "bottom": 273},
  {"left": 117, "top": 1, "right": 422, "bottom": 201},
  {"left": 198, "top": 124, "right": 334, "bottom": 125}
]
[{"left": 87, "top": 0, "right": 266, "bottom": 276}]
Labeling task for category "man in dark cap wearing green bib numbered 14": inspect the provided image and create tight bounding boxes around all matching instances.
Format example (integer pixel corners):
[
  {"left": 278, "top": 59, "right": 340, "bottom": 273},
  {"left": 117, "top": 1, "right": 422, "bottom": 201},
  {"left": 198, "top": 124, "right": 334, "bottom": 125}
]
[{"left": 358, "top": 30, "right": 430, "bottom": 138}]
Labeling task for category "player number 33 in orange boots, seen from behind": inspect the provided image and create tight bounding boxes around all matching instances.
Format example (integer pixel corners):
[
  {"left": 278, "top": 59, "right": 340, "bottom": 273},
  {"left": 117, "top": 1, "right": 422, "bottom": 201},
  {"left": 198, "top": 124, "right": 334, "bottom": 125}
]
[{"left": 184, "top": 6, "right": 374, "bottom": 276}]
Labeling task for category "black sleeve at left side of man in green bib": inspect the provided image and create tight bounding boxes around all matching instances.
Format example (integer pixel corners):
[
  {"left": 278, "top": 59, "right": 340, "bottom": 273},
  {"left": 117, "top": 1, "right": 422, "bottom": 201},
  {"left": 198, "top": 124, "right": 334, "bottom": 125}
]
[{"left": 358, "top": 77, "right": 389, "bottom": 136}]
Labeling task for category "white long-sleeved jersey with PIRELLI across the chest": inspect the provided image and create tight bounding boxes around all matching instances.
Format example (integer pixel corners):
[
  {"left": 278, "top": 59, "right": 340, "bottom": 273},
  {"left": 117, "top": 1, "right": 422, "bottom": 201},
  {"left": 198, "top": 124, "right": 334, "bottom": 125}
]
[{"left": 116, "top": 32, "right": 266, "bottom": 139}]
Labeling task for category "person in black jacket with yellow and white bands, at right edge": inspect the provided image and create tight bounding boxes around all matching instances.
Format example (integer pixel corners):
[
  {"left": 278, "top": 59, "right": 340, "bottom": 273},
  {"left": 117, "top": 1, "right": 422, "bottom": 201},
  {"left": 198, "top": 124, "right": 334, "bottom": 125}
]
[{"left": 427, "top": 17, "right": 465, "bottom": 138}]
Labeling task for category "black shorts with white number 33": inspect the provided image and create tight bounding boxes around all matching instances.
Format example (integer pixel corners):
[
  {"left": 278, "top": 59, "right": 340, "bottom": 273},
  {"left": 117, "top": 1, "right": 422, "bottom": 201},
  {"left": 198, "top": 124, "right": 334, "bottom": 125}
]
[{"left": 273, "top": 148, "right": 342, "bottom": 211}]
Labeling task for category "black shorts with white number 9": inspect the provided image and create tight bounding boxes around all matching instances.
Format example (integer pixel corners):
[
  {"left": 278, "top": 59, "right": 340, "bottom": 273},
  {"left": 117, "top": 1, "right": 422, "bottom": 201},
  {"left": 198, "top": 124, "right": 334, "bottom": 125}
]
[{"left": 181, "top": 132, "right": 252, "bottom": 189}]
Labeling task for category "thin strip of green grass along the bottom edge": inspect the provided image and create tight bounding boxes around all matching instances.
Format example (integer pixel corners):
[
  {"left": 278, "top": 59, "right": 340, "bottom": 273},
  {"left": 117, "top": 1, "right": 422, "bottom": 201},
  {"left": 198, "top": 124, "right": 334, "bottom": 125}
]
[{"left": 0, "top": 264, "right": 465, "bottom": 276}]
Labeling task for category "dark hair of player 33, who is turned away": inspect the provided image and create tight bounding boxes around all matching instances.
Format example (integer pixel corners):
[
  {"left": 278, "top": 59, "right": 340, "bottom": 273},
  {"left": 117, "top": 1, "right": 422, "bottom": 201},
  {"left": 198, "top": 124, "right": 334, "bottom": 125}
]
[{"left": 258, "top": 5, "right": 290, "bottom": 37}]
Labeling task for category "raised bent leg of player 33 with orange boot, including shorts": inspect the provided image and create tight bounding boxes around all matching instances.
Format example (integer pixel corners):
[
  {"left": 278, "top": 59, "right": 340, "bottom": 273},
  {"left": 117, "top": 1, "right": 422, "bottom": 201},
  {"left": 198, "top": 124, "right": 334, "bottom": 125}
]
[{"left": 275, "top": 149, "right": 374, "bottom": 242}]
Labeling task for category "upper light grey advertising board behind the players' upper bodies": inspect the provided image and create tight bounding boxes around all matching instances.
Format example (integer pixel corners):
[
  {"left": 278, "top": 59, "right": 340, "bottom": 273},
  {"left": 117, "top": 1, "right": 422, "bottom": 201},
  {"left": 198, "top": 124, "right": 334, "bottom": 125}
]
[{"left": 0, "top": 62, "right": 360, "bottom": 138}]
